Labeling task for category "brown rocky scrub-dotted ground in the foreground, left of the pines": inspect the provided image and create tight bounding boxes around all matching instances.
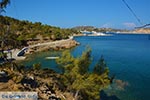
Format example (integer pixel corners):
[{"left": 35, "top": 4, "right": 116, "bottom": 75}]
[{"left": 0, "top": 64, "right": 74, "bottom": 100}]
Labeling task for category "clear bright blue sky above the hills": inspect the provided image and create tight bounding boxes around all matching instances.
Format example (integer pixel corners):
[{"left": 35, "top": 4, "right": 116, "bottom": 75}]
[{"left": 3, "top": 0, "right": 150, "bottom": 29}]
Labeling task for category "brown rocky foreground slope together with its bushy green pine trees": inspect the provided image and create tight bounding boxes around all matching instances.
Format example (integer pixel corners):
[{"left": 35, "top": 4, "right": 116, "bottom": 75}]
[{"left": 0, "top": 50, "right": 111, "bottom": 100}]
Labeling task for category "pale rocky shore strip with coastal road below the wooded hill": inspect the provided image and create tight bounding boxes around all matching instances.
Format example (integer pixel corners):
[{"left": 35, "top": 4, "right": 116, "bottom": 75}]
[{"left": 6, "top": 39, "right": 80, "bottom": 60}]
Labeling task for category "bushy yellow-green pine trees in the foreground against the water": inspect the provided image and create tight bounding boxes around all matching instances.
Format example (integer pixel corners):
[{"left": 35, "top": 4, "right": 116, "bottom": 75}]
[{"left": 57, "top": 50, "right": 111, "bottom": 100}]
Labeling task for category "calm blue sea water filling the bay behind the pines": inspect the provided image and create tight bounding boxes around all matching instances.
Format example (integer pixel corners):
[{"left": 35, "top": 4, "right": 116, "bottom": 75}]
[{"left": 24, "top": 34, "right": 150, "bottom": 100}]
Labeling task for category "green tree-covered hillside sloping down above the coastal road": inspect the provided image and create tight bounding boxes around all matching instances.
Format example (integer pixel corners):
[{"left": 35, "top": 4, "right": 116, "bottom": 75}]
[{"left": 0, "top": 15, "right": 78, "bottom": 48}]
